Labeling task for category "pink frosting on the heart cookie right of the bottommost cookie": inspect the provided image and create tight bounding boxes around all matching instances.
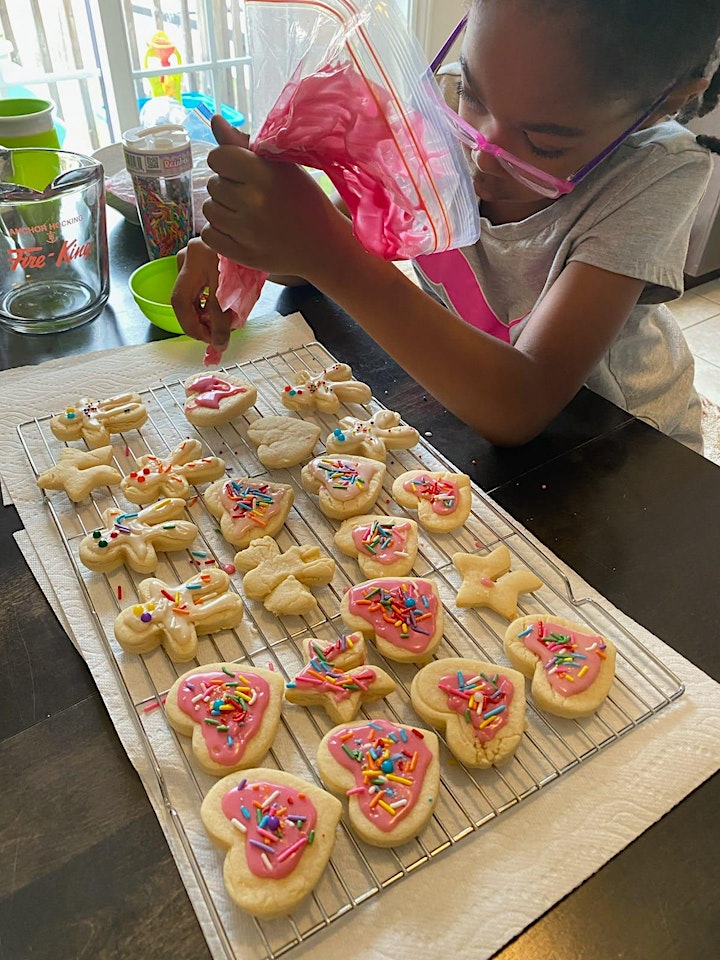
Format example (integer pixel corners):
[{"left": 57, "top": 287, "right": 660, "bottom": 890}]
[{"left": 327, "top": 720, "right": 433, "bottom": 831}]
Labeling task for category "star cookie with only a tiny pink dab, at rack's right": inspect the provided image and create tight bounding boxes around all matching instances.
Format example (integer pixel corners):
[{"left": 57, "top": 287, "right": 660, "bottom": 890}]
[{"left": 452, "top": 544, "right": 543, "bottom": 620}]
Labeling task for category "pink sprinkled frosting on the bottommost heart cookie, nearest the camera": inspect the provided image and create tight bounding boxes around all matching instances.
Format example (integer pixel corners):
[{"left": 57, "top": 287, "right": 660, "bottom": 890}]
[{"left": 222, "top": 780, "right": 317, "bottom": 880}]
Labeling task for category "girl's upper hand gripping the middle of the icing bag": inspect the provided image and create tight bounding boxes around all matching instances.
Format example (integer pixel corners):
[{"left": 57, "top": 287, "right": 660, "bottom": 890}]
[{"left": 202, "top": 116, "right": 351, "bottom": 280}]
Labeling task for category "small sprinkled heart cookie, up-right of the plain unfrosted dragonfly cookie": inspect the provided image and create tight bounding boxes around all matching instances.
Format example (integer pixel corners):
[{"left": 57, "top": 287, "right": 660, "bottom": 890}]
[{"left": 335, "top": 513, "right": 418, "bottom": 578}]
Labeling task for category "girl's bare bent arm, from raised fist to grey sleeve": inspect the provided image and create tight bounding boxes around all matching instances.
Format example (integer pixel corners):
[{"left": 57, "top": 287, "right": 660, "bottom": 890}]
[{"left": 197, "top": 120, "right": 643, "bottom": 445}]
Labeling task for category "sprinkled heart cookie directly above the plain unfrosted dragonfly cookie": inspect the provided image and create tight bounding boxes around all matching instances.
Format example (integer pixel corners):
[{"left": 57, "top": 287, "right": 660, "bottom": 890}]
[{"left": 204, "top": 477, "right": 295, "bottom": 549}]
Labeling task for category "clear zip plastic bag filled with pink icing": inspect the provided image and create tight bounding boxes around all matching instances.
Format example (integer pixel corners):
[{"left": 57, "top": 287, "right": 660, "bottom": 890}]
[{"left": 218, "top": 0, "right": 480, "bottom": 352}]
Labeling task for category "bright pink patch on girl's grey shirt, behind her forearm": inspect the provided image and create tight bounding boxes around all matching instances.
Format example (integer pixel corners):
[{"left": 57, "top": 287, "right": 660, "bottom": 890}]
[{"left": 415, "top": 250, "right": 522, "bottom": 343}]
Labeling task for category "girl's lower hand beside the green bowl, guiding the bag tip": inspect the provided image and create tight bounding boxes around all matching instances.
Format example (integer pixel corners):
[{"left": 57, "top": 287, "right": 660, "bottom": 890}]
[{"left": 170, "top": 238, "right": 235, "bottom": 351}]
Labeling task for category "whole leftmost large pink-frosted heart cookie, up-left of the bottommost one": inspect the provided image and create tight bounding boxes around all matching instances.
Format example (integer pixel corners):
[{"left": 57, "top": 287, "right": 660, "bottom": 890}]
[{"left": 165, "top": 663, "right": 285, "bottom": 777}]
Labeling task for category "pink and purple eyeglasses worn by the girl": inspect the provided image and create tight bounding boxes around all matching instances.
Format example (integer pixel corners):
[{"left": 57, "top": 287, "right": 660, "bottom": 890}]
[{"left": 430, "top": 13, "right": 675, "bottom": 200}]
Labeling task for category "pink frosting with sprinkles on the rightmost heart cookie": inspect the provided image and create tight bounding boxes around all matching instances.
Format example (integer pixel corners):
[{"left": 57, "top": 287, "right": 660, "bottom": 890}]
[{"left": 518, "top": 620, "right": 607, "bottom": 697}]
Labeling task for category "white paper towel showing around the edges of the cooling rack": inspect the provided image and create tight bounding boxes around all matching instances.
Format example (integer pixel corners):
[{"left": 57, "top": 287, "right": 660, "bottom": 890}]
[{"left": 0, "top": 320, "right": 720, "bottom": 960}]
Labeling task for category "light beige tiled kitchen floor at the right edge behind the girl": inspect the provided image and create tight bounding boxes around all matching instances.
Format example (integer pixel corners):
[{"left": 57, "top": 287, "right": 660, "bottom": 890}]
[{"left": 668, "top": 278, "right": 720, "bottom": 405}]
